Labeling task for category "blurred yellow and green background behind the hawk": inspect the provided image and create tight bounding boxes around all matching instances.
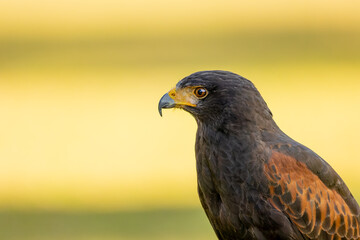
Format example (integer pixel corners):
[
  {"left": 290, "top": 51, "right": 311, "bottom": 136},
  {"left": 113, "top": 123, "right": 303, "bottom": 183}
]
[{"left": 0, "top": 0, "right": 360, "bottom": 240}]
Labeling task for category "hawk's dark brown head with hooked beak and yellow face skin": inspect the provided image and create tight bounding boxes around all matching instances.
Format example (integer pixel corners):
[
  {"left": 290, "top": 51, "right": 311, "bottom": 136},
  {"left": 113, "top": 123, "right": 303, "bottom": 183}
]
[{"left": 159, "top": 71, "right": 274, "bottom": 130}]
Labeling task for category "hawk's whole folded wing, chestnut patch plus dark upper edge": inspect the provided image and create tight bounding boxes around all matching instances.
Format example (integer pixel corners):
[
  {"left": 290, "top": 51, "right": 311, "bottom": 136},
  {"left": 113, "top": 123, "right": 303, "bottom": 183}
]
[{"left": 264, "top": 136, "right": 360, "bottom": 239}]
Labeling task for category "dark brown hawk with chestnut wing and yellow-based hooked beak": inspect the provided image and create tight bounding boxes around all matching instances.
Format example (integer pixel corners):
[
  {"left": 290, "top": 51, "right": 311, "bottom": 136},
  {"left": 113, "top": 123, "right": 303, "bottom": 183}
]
[{"left": 158, "top": 70, "right": 360, "bottom": 240}]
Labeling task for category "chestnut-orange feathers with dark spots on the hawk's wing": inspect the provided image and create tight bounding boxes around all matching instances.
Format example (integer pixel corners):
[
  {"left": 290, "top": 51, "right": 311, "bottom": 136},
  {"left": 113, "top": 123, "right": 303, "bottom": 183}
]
[{"left": 264, "top": 151, "right": 360, "bottom": 239}]
